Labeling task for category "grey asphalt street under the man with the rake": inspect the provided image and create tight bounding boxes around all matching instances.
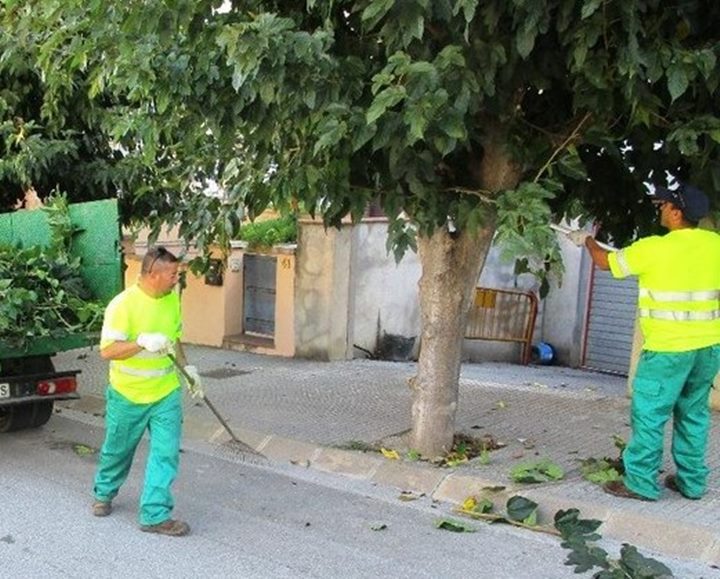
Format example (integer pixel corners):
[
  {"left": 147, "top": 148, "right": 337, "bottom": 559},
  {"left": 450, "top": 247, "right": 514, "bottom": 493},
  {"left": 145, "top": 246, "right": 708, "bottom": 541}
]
[{"left": 0, "top": 416, "right": 600, "bottom": 579}]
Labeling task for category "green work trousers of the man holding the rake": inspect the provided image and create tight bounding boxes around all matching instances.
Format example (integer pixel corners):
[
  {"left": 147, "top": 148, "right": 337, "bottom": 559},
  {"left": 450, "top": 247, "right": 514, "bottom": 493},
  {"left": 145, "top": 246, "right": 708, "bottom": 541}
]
[{"left": 94, "top": 387, "right": 182, "bottom": 525}]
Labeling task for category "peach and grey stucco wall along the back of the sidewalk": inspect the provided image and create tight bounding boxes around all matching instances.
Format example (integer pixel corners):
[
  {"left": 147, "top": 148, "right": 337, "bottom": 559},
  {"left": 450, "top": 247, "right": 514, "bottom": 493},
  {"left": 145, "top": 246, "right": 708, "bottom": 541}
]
[{"left": 126, "top": 218, "right": 587, "bottom": 365}]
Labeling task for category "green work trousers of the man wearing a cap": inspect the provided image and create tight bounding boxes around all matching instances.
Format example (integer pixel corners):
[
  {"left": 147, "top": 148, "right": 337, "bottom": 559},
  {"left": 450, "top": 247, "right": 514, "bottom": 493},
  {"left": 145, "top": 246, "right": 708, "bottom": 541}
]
[{"left": 623, "top": 346, "right": 720, "bottom": 500}]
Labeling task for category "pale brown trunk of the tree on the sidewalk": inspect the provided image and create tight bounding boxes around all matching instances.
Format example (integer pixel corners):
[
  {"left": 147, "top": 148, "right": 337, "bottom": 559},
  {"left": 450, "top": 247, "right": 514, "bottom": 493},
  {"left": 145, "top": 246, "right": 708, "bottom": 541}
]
[{"left": 410, "top": 126, "right": 522, "bottom": 458}]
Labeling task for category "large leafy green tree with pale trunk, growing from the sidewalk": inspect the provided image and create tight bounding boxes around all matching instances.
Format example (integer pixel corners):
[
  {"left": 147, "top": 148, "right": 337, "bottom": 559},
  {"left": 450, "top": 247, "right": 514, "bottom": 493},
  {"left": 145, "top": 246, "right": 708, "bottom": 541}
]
[{"left": 0, "top": 0, "right": 720, "bottom": 458}]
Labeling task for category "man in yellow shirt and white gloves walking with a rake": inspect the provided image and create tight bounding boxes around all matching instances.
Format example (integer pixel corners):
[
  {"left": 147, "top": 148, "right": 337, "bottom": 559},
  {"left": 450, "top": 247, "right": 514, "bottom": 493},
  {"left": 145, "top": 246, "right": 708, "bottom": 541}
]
[{"left": 93, "top": 247, "right": 200, "bottom": 536}]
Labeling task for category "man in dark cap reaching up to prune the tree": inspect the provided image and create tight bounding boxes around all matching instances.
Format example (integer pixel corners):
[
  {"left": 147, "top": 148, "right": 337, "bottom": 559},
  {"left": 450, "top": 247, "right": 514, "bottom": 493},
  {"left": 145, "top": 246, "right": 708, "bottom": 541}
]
[{"left": 568, "top": 185, "right": 720, "bottom": 500}]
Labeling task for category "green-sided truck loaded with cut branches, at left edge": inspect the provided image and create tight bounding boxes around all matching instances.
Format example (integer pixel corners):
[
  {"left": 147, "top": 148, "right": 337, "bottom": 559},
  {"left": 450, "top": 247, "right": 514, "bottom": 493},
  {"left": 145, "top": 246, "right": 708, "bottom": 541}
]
[{"left": 0, "top": 199, "right": 123, "bottom": 433}]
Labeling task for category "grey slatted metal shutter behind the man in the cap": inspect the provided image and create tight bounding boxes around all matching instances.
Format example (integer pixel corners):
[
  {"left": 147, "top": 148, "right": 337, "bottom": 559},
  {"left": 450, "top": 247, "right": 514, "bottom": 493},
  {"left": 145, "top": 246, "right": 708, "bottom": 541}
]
[{"left": 583, "top": 268, "right": 638, "bottom": 375}]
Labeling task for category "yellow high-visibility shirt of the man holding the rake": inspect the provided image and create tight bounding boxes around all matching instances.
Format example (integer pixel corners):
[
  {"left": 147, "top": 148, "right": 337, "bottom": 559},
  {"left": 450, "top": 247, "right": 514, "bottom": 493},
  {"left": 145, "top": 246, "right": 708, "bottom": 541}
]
[{"left": 100, "top": 284, "right": 182, "bottom": 404}]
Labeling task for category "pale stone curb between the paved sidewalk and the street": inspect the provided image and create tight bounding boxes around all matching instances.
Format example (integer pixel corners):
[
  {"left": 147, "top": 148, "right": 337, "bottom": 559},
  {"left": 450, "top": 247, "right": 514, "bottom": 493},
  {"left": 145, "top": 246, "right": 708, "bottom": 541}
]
[{"left": 61, "top": 396, "right": 720, "bottom": 566}]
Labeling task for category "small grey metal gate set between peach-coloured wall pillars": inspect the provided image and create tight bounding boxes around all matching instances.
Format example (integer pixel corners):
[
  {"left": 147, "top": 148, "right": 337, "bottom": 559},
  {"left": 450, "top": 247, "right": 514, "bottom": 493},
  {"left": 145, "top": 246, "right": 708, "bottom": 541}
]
[{"left": 243, "top": 254, "right": 277, "bottom": 337}]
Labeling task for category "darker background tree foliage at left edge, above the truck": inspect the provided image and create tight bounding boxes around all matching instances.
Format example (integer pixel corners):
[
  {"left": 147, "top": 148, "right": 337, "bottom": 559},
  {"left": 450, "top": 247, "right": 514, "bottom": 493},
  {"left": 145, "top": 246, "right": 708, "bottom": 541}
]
[{"left": 0, "top": 24, "right": 120, "bottom": 210}]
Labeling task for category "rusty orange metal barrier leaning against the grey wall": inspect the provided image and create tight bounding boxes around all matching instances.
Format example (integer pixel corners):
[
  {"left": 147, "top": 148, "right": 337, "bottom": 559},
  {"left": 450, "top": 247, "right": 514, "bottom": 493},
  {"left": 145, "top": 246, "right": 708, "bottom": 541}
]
[{"left": 465, "top": 287, "right": 538, "bottom": 364}]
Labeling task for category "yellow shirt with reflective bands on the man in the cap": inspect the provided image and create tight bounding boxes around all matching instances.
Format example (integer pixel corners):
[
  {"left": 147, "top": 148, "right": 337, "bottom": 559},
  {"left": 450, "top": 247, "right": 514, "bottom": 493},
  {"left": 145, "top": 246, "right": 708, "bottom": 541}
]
[{"left": 608, "top": 228, "right": 720, "bottom": 352}]
